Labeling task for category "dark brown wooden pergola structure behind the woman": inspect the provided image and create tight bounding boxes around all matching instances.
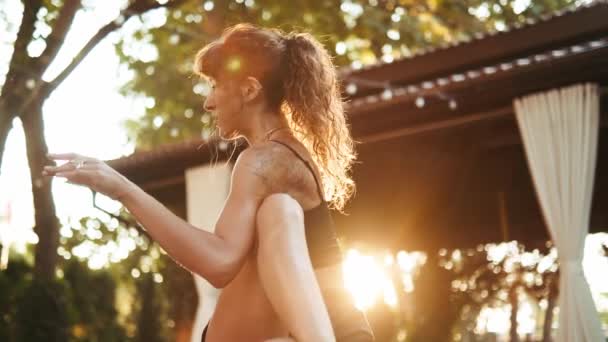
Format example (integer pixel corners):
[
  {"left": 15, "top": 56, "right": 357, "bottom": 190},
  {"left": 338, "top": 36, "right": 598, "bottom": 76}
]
[{"left": 110, "top": 2, "right": 608, "bottom": 251}]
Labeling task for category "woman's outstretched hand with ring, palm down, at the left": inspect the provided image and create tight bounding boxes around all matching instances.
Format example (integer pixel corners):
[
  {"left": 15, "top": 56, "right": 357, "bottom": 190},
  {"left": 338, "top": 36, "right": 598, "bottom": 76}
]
[{"left": 42, "top": 153, "right": 132, "bottom": 201}]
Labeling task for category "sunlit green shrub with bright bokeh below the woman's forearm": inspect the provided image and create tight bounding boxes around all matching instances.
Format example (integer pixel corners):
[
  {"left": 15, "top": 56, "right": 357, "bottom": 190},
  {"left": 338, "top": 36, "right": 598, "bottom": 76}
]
[{"left": 60, "top": 211, "right": 198, "bottom": 341}]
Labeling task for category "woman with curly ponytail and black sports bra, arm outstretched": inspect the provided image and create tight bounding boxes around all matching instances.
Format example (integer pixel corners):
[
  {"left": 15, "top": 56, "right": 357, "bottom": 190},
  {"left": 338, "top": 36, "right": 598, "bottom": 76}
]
[{"left": 44, "top": 24, "right": 373, "bottom": 342}]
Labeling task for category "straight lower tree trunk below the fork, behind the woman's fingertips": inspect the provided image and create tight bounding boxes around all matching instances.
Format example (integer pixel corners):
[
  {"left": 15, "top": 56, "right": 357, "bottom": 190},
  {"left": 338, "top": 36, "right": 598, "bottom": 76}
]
[{"left": 21, "top": 100, "right": 59, "bottom": 280}]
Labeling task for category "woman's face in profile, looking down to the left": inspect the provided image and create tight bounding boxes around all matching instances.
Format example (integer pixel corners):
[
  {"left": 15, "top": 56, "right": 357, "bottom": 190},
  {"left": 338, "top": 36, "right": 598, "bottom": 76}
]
[{"left": 204, "top": 80, "right": 243, "bottom": 139}]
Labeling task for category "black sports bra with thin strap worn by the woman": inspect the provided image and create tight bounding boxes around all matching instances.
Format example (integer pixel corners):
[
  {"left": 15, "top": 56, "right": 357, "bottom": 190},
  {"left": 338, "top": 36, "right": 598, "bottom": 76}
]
[{"left": 269, "top": 139, "right": 342, "bottom": 268}]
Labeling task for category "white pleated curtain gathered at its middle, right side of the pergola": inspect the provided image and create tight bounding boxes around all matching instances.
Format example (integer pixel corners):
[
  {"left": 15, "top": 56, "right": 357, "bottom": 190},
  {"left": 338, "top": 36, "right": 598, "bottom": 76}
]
[{"left": 514, "top": 84, "right": 604, "bottom": 342}]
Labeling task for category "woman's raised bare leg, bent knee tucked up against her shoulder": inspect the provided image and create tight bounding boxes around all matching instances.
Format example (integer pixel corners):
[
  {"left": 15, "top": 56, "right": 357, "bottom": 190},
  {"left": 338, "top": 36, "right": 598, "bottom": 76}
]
[{"left": 257, "top": 194, "right": 336, "bottom": 342}]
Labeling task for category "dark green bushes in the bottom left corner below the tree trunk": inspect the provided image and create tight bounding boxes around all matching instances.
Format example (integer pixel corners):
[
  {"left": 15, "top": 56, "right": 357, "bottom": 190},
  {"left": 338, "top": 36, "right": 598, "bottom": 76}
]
[{"left": 0, "top": 255, "right": 127, "bottom": 342}]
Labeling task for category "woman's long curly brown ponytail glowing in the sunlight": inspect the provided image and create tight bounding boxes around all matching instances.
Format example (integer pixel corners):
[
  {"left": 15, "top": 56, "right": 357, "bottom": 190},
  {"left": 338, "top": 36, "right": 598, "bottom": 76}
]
[{"left": 283, "top": 33, "right": 356, "bottom": 211}]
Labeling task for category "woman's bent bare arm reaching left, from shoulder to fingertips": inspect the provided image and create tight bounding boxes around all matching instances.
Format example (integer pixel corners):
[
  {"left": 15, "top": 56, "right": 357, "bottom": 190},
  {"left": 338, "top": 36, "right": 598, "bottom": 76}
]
[{"left": 45, "top": 150, "right": 265, "bottom": 288}]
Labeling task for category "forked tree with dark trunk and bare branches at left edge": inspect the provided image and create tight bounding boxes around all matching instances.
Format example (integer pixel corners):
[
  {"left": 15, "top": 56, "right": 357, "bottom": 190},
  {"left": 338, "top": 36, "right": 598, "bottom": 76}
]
[{"left": 0, "top": 0, "right": 189, "bottom": 280}]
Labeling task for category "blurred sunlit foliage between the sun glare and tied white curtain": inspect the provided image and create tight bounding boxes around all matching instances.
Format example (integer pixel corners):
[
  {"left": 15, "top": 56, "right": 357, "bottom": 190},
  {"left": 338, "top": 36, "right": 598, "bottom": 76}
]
[{"left": 439, "top": 241, "right": 559, "bottom": 340}]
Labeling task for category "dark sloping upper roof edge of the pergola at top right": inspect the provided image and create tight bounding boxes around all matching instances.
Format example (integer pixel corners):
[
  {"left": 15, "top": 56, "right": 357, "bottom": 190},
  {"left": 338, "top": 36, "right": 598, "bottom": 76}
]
[{"left": 341, "top": 0, "right": 608, "bottom": 94}]
